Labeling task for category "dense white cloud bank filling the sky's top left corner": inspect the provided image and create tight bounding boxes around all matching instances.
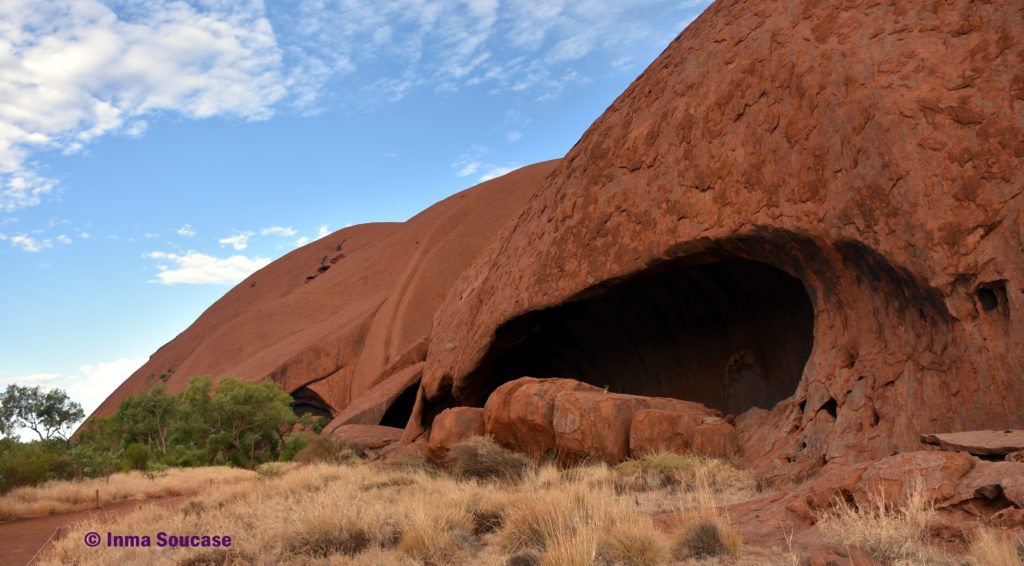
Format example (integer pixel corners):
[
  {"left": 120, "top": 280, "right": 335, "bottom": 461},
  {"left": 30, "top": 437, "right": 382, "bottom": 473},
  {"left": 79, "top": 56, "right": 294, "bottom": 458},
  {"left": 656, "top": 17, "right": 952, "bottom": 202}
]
[{"left": 0, "top": 0, "right": 286, "bottom": 212}]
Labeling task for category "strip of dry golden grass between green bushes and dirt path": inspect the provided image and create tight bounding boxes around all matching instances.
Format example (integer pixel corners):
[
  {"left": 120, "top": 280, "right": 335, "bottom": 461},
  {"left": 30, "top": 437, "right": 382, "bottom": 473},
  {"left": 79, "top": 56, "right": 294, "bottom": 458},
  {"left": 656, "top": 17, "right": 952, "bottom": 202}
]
[{"left": 0, "top": 468, "right": 257, "bottom": 521}]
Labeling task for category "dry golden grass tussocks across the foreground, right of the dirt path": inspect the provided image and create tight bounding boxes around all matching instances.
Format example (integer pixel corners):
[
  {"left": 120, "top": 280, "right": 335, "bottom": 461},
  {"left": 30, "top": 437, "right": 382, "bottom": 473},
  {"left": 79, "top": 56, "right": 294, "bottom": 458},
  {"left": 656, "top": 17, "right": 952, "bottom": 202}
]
[{"left": 32, "top": 439, "right": 1021, "bottom": 566}]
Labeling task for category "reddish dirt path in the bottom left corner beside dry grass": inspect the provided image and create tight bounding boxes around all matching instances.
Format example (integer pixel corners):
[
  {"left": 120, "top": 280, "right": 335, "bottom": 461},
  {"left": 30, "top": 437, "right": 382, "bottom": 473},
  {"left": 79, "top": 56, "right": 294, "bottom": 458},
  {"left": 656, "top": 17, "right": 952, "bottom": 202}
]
[{"left": 0, "top": 495, "right": 191, "bottom": 566}]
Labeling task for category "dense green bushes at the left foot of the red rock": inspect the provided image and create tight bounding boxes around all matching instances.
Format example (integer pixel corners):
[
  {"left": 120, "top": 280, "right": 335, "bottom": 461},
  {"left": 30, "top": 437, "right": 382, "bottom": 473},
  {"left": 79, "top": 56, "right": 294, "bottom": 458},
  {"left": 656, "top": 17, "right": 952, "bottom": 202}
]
[{"left": 0, "top": 377, "right": 307, "bottom": 493}]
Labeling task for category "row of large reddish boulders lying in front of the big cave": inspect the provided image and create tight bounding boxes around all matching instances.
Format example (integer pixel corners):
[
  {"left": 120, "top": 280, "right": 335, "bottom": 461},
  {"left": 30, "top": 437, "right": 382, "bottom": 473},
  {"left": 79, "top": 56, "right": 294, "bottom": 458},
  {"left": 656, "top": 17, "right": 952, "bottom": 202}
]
[{"left": 481, "top": 378, "right": 735, "bottom": 464}]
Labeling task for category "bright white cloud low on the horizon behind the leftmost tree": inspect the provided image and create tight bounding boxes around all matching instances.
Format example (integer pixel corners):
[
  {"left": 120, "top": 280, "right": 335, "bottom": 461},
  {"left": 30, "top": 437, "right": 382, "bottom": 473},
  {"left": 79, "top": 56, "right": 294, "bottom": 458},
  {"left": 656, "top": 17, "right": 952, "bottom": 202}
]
[{"left": 0, "top": 357, "right": 146, "bottom": 421}]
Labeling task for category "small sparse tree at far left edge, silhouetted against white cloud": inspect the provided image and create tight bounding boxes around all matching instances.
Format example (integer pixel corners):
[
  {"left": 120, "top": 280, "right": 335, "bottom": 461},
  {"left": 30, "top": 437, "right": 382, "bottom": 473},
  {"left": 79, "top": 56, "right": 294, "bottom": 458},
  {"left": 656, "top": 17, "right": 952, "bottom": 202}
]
[{"left": 0, "top": 385, "right": 85, "bottom": 440}]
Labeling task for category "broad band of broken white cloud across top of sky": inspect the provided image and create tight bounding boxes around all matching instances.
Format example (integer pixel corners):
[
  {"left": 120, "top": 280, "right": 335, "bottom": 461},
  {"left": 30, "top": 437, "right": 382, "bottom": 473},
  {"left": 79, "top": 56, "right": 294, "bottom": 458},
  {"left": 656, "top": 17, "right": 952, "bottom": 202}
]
[{"left": 0, "top": 0, "right": 710, "bottom": 213}]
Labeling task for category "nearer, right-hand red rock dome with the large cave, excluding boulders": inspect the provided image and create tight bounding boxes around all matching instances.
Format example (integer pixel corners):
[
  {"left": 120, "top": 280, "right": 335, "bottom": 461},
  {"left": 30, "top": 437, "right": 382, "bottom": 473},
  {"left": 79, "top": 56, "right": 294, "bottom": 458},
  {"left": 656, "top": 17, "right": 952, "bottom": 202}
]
[{"left": 411, "top": 0, "right": 1024, "bottom": 478}]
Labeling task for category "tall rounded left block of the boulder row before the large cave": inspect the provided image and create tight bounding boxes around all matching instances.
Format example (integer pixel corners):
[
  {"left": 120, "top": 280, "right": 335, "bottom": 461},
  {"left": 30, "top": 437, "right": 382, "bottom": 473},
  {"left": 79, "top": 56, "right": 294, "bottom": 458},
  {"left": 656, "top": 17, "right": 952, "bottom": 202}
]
[{"left": 483, "top": 378, "right": 601, "bottom": 459}]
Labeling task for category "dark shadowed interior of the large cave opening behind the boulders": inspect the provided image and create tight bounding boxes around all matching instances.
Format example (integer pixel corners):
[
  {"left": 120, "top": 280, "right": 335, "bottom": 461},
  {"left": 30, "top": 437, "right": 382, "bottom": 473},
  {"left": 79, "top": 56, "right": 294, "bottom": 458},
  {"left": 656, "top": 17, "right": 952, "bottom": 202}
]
[{"left": 459, "top": 258, "right": 814, "bottom": 415}]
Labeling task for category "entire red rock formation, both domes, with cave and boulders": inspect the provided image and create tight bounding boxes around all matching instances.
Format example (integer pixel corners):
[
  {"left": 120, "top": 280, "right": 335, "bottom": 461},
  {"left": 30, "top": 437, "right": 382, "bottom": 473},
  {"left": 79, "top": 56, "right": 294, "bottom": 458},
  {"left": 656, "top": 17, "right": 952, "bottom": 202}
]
[{"left": 99, "top": 0, "right": 1024, "bottom": 485}]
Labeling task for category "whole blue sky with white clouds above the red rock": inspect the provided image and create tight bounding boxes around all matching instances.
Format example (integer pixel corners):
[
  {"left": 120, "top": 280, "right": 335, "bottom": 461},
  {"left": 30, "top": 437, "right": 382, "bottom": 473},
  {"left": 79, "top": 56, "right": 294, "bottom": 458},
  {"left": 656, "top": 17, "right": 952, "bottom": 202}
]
[{"left": 0, "top": 0, "right": 710, "bottom": 412}]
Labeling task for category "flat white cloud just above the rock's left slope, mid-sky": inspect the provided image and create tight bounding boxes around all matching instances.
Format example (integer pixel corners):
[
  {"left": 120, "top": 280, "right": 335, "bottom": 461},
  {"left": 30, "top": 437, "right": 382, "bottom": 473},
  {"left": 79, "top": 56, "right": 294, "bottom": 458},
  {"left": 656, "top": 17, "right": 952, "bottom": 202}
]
[{"left": 146, "top": 250, "right": 270, "bottom": 285}]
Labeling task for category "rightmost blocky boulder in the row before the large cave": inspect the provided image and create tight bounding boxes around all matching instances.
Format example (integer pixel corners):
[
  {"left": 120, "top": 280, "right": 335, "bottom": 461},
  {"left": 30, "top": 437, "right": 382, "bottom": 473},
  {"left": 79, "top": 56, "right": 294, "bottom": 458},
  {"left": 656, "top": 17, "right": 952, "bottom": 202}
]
[{"left": 630, "top": 405, "right": 737, "bottom": 458}]
